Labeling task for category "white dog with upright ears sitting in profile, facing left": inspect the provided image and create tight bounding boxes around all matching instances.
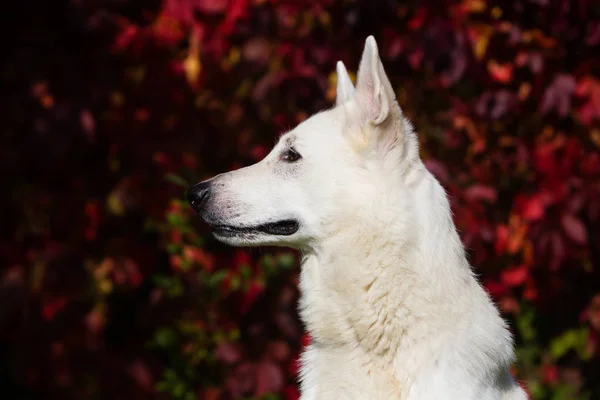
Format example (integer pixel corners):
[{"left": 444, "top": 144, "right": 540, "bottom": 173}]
[{"left": 188, "top": 37, "right": 526, "bottom": 400}]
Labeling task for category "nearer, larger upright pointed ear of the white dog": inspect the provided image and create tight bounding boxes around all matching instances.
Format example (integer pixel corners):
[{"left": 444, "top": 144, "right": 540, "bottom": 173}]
[{"left": 356, "top": 36, "right": 396, "bottom": 125}]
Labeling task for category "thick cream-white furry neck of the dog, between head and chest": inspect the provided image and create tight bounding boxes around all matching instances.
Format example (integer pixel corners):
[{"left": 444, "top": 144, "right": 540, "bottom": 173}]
[{"left": 300, "top": 168, "right": 506, "bottom": 366}]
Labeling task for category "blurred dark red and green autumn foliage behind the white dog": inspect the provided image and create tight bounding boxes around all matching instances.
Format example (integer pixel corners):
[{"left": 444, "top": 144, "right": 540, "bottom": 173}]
[{"left": 0, "top": 0, "right": 600, "bottom": 400}]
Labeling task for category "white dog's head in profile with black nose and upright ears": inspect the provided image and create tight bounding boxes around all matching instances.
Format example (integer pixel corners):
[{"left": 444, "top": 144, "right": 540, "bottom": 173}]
[{"left": 187, "top": 36, "right": 418, "bottom": 248}]
